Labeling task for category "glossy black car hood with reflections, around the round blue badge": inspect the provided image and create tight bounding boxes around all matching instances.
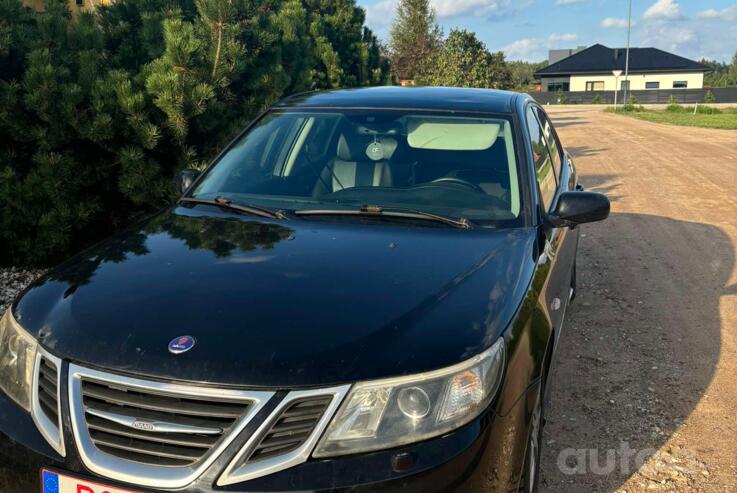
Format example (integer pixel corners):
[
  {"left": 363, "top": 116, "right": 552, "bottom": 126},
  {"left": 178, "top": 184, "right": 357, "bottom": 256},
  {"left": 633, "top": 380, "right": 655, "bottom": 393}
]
[{"left": 15, "top": 205, "right": 535, "bottom": 388}]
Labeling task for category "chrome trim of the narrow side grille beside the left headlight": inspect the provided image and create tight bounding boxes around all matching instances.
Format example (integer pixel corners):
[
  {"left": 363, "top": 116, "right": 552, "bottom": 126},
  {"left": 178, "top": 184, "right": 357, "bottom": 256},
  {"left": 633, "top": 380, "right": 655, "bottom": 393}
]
[{"left": 31, "top": 346, "right": 66, "bottom": 457}]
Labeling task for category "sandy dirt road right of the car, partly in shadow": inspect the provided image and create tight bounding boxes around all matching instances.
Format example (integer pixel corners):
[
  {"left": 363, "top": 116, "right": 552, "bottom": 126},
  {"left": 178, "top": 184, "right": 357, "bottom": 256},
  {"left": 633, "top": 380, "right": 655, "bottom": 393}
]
[{"left": 542, "top": 107, "right": 737, "bottom": 493}]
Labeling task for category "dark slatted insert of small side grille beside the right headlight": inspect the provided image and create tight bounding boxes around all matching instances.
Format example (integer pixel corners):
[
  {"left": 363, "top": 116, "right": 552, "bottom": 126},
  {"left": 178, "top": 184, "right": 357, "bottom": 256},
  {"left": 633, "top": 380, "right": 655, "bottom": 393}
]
[{"left": 247, "top": 395, "right": 333, "bottom": 462}]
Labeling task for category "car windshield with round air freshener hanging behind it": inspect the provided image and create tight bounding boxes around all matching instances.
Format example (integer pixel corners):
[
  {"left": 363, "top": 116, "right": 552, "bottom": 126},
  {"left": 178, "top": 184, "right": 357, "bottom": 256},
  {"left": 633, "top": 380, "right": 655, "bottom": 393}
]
[{"left": 188, "top": 110, "right": 521, "bottom": 226}]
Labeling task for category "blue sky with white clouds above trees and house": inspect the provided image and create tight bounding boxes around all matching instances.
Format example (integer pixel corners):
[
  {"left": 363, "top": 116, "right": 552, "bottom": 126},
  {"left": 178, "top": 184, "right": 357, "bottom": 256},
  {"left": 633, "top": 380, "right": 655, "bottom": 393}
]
[{"left": 358, "top": 0, "right": 737, "bottom": 62}]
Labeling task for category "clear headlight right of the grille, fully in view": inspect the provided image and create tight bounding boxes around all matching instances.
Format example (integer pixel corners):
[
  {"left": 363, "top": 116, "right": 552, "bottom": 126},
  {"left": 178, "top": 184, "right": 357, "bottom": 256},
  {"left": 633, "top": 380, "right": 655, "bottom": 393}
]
[{"left": 313, "top": 339, "right": 504, "bottom": 457}]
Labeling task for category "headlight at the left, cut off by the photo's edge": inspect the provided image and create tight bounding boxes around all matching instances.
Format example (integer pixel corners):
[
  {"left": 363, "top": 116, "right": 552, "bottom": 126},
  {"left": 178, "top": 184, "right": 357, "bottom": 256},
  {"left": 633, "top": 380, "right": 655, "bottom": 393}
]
[{"left": 0, "top": 308, "right": 36, "bottom": 411}]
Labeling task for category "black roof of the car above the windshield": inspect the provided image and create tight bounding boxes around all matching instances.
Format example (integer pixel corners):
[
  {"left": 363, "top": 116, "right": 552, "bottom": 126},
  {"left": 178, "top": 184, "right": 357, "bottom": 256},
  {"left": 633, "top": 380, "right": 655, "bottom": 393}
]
[{"left": 275, "top": 86, "right": 529, "bottom": 113}]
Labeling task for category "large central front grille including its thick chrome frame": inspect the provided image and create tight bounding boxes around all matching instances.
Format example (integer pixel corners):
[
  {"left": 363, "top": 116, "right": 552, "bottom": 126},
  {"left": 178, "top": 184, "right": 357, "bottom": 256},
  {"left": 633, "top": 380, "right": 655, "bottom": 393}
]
[{"left": 68, "top": 363, "right": 275, "bottom": 490}]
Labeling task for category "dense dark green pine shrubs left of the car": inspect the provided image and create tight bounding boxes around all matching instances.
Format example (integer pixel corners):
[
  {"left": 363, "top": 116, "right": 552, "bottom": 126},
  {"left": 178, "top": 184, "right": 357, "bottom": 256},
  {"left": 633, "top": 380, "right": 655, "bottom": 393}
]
[{"left": 0, "top": 0, "right": 388, "bottom": 265}]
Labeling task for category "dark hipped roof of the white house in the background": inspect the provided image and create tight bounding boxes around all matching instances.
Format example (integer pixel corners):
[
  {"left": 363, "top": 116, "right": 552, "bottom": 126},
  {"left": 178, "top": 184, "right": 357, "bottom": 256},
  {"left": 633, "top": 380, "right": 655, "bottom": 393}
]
[{"left": 535, "top": 44, "right": 710, "bottom": 77}]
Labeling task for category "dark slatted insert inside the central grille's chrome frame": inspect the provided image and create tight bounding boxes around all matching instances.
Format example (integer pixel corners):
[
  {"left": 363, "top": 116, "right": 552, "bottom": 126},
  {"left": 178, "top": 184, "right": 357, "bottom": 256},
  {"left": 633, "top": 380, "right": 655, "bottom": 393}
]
[{"left": 81, "top": 379, "right": 249, "bottom": 466}]
